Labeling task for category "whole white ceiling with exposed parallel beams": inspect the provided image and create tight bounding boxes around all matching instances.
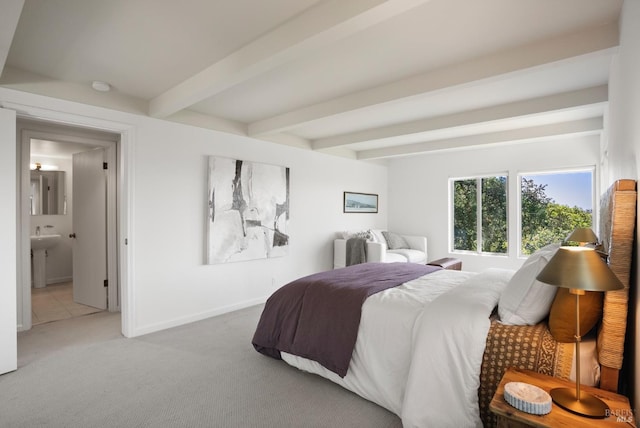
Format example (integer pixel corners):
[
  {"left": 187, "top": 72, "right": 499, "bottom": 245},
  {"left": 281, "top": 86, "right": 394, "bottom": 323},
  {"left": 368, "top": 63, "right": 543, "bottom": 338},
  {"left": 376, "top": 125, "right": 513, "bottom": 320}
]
[{"left": 0, "top": 0, "right": 622, "bottom": 159}]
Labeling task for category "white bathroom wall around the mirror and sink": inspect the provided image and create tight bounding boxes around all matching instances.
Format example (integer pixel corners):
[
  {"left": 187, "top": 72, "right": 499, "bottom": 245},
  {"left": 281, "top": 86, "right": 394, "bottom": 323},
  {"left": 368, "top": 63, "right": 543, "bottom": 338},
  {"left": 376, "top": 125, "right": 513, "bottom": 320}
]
[{"left": 29, "top": 156, "right": 73, "bottom": 284}]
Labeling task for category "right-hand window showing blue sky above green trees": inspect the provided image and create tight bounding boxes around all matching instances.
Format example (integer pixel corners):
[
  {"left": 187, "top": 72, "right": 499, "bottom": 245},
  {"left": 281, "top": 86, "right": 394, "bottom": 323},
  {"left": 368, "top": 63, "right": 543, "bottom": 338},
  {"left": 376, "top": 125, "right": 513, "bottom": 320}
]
[{"left": 520, "top": 169, "right": 594, "bottom": 255}]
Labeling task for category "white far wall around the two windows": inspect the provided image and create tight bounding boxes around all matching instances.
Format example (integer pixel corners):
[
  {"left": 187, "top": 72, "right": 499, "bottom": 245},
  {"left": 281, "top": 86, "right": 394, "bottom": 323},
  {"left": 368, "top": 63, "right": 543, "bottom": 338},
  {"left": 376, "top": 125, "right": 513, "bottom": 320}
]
[{"left": 388, "top": 135, "right": 600, "bottom": 271}]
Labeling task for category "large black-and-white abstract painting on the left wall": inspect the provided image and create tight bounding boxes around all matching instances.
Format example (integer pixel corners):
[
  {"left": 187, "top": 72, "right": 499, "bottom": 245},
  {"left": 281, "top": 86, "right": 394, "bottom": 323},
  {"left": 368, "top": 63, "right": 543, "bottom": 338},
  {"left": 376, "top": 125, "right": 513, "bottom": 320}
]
[{"left": 207, "top": 156, "right": 289, "bottom": 264}]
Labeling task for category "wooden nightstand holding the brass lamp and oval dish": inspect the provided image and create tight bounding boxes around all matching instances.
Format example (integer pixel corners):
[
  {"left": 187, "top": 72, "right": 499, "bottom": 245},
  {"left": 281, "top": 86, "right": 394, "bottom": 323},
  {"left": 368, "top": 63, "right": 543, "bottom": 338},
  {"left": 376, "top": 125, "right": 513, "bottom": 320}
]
[{"left": 489, "top": 368, "right": 636, "bottom": 428}]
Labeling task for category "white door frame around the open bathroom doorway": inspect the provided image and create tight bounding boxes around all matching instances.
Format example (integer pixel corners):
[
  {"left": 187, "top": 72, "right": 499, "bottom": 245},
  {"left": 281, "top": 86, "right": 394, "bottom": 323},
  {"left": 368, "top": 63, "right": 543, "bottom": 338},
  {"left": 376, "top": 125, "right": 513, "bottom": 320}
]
[{"left": 9, "top": 102, "right": 136, "bottom": 337}]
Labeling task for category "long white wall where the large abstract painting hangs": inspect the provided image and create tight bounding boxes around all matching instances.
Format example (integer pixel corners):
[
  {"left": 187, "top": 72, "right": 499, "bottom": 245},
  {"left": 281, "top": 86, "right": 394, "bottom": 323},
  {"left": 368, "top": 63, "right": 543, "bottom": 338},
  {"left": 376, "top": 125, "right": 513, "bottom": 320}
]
[{"left": 0, "top": 88, "right": 387, "bottom": 336}]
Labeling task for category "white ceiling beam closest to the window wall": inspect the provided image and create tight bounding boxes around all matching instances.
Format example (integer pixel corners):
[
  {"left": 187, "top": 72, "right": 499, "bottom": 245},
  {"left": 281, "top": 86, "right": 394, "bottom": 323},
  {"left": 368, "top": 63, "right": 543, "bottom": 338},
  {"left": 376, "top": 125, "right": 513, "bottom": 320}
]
[{"left": 356, "top": 117, "right": 604, "bottom": 160}]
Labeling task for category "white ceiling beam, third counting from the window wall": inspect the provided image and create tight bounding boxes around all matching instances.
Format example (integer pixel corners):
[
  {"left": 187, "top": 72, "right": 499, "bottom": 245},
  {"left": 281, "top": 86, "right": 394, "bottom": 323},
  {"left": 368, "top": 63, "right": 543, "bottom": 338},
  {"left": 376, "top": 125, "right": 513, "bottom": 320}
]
[{"left": 248, "top": 23, "right": 619, "bottom": 137}]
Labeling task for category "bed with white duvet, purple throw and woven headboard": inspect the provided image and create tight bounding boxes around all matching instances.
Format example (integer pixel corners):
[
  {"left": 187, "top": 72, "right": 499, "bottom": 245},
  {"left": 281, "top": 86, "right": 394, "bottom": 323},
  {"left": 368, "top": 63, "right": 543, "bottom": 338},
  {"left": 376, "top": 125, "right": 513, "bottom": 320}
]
[{"left": 253, "top": 180, "right": 636, "bottom": 427}]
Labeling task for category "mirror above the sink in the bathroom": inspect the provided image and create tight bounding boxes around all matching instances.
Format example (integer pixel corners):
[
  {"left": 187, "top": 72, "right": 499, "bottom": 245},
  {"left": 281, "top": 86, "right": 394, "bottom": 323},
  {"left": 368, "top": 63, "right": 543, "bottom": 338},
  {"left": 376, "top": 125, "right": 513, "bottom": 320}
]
[{"left": 30, "top": 170, "right": 67, "bottom": 215}]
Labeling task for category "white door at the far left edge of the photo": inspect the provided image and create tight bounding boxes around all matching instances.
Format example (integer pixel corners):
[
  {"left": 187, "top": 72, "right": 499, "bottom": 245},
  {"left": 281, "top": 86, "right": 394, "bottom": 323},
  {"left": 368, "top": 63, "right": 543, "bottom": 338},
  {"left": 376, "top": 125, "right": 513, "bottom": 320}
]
[{"left": 0, "top": 108, "right": 18, "bottom": 374}]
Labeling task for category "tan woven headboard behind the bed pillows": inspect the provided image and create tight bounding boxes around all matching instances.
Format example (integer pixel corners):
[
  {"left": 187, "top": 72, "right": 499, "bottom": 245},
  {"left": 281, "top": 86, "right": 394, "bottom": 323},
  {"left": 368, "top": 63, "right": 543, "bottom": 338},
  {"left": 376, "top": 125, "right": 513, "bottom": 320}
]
[{"left": 597, "top": 180, "right": 637, "bottom": 391}]
